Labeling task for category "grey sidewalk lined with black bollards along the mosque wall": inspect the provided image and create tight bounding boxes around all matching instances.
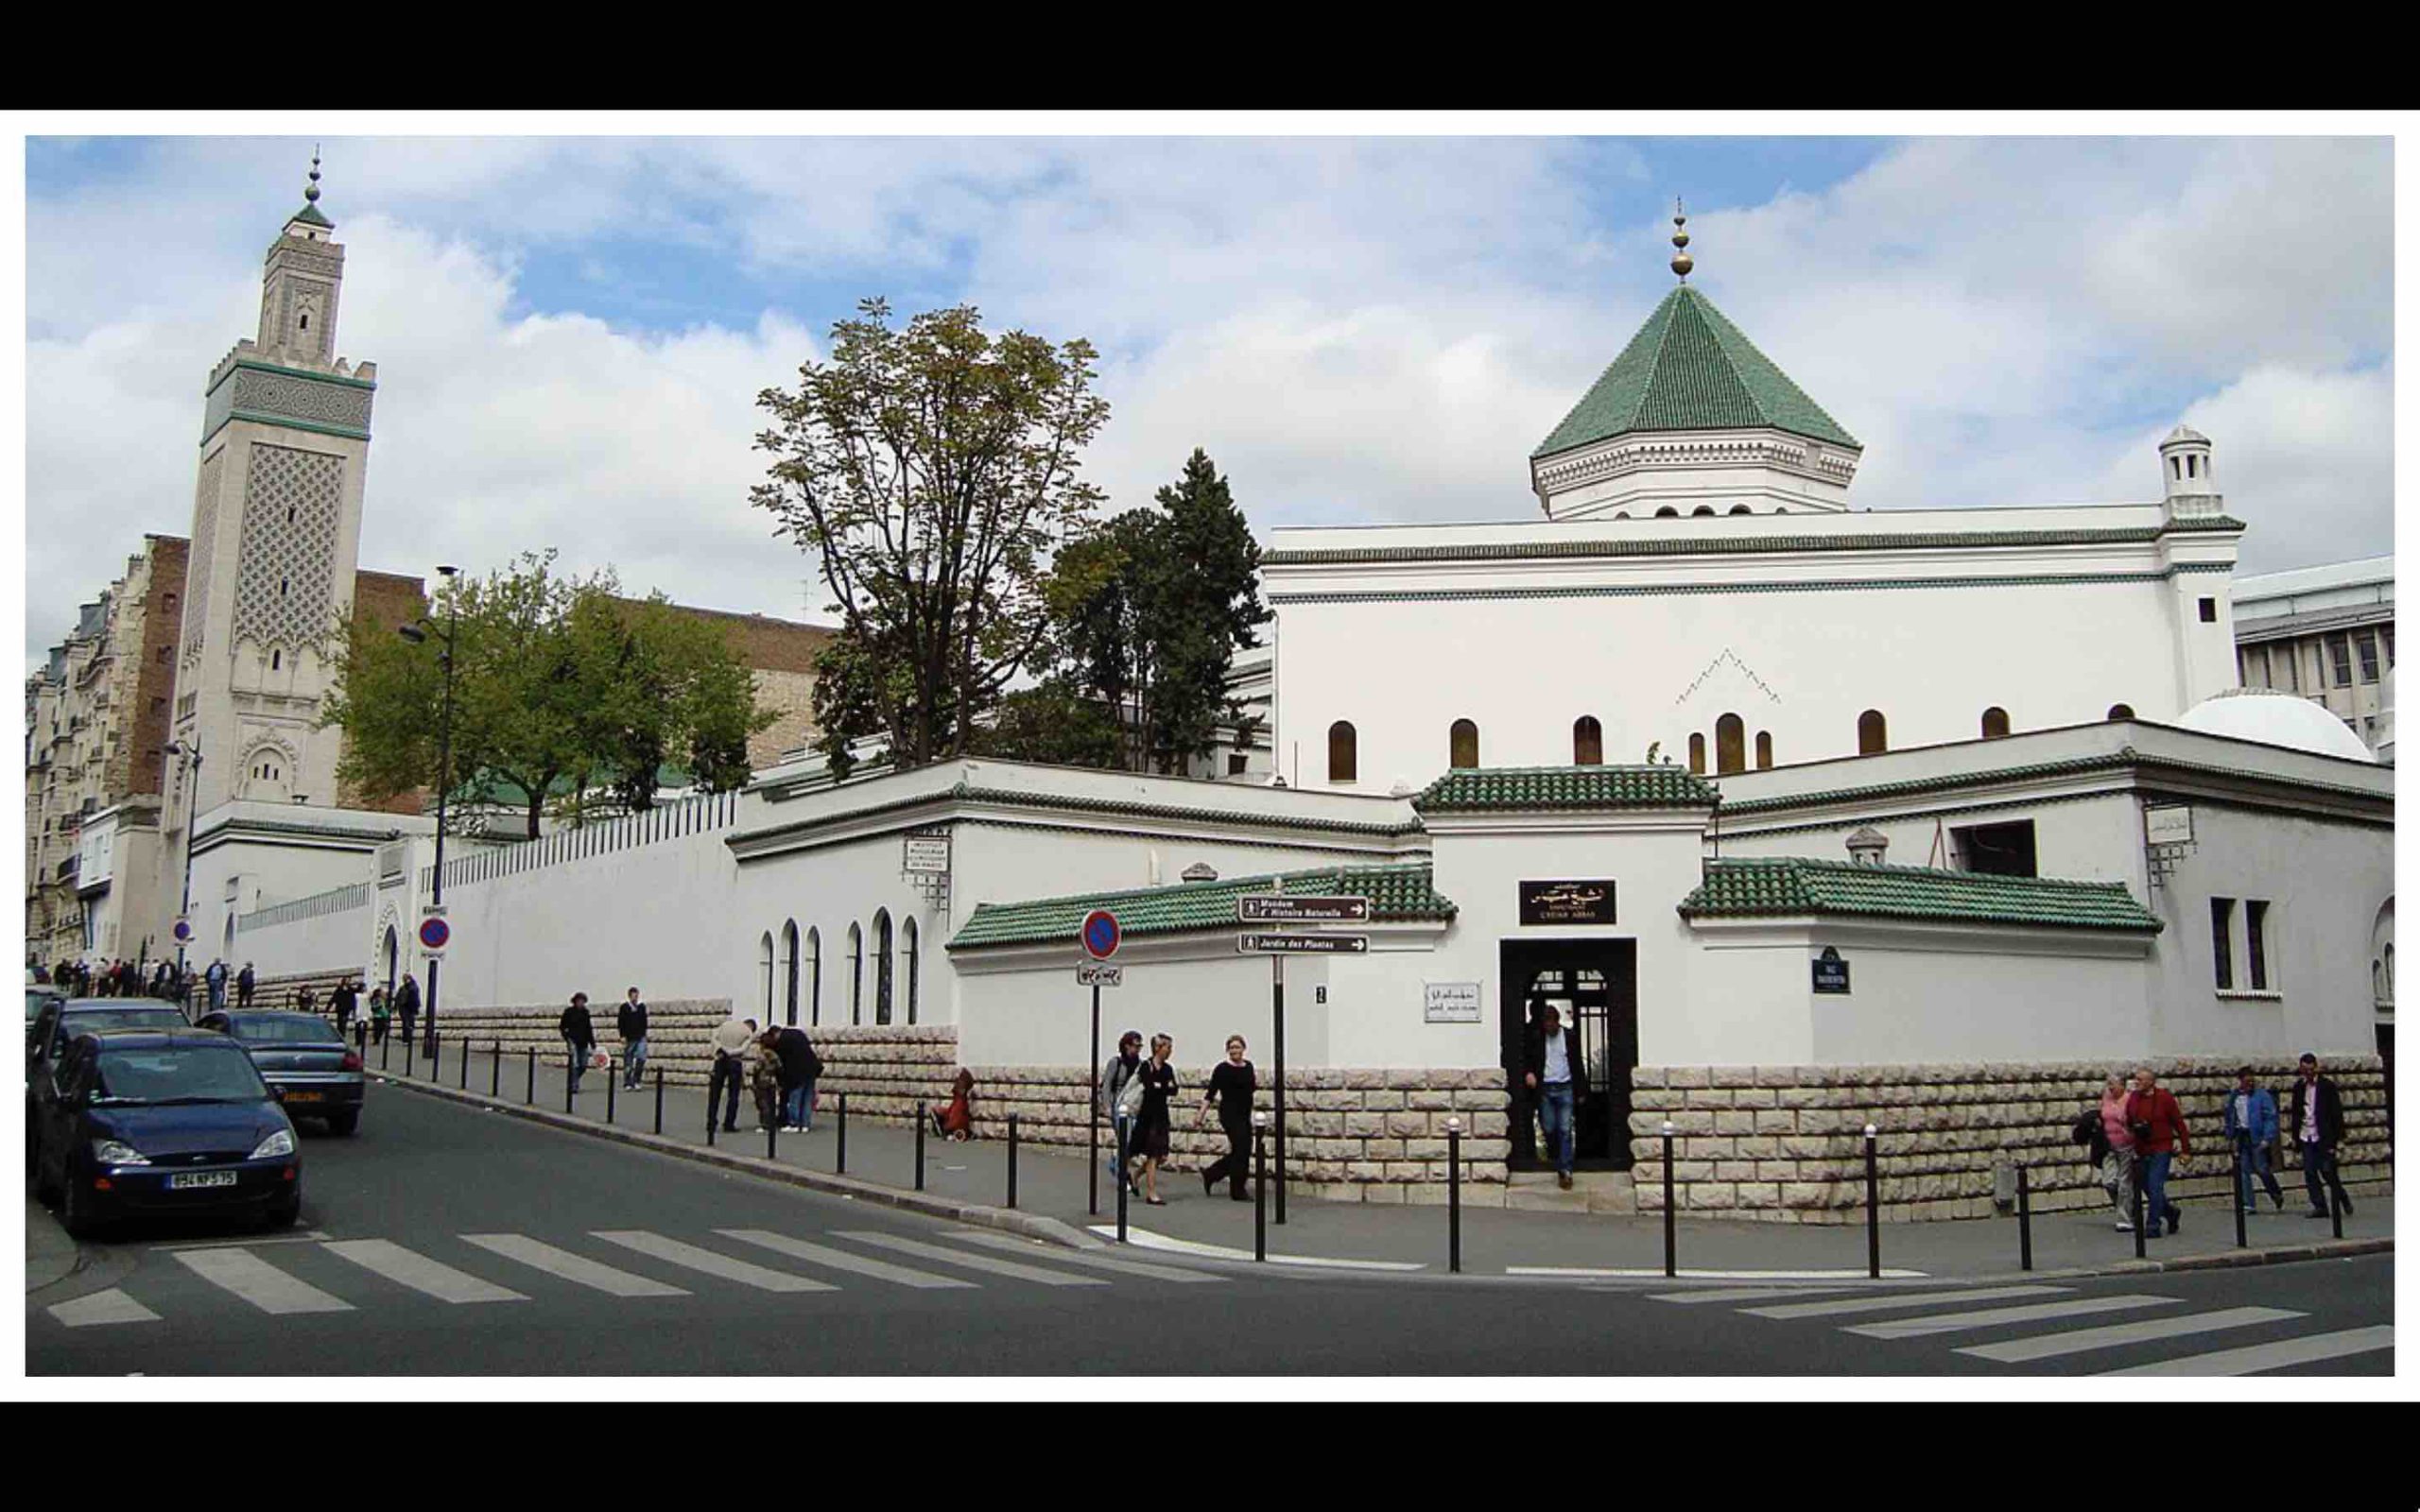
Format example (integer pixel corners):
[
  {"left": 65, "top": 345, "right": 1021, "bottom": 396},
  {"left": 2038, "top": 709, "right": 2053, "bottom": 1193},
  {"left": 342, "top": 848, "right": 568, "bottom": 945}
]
[{"left": 366, "top": 1053, "right": 2394, "bottom": 1280}]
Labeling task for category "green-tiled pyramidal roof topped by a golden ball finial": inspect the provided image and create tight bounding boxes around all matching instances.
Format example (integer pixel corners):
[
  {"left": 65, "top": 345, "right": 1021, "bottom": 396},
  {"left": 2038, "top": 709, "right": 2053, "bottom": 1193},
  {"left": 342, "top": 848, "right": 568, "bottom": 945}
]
[{"left": 1530, "top": 285, "right": 1863, "bottom": 457}]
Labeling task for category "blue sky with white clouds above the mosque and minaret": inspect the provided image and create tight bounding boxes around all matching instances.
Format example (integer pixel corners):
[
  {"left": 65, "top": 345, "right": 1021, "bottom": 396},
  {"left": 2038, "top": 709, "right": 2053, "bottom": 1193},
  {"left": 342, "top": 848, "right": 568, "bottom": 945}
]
[{"left": 25, "top": 138, "right": 2394, "bottom": 665}]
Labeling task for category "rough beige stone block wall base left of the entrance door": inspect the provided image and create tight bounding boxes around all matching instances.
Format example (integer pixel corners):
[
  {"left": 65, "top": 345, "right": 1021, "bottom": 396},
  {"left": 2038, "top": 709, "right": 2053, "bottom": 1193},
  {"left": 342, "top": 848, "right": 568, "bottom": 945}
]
[{"left": 948, "top": 1050, "right": 1510, "bottom": 1207}]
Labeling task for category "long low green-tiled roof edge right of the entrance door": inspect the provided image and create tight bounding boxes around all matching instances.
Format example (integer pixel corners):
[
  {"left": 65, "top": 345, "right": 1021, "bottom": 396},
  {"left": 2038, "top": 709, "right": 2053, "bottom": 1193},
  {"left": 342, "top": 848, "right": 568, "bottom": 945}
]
[{"left": 1680, "top": 856, "right": 2161, "bottom": 934}]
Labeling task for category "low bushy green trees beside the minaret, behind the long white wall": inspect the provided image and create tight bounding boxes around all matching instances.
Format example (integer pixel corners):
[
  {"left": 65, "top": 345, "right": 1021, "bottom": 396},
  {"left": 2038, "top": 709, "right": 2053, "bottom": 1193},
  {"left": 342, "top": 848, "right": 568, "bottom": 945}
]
[{"left": 320, "top": 552, "right": 774, "bottom": 839}]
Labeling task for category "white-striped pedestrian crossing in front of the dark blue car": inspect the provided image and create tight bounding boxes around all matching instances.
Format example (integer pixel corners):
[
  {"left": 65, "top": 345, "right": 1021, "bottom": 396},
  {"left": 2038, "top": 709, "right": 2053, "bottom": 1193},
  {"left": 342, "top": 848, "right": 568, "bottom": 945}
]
[{"left": 46, "top": 1228, "right": 1227, "bottom": 1328}]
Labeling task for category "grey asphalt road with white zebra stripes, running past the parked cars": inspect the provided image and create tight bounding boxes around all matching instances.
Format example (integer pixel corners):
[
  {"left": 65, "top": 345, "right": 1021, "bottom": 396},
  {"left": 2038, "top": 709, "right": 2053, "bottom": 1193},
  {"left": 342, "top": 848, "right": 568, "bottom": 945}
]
[{"left": 26, "top": 1089, "right": 2394, "bottom": 1377}]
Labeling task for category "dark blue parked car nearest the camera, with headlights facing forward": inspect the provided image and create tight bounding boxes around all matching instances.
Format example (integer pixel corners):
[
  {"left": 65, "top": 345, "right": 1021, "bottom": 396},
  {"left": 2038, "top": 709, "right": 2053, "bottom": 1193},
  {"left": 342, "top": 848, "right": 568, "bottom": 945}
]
[{"left": 31, "top": 1028, "right": 302, "bottom": 1239}]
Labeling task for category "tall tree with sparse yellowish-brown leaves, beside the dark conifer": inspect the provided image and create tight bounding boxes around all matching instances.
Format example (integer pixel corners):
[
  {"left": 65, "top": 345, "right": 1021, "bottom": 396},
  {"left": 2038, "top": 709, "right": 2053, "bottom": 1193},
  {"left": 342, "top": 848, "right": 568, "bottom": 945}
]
[{"left": 751, "top": 300, "right": 1108, "bottom": 769}]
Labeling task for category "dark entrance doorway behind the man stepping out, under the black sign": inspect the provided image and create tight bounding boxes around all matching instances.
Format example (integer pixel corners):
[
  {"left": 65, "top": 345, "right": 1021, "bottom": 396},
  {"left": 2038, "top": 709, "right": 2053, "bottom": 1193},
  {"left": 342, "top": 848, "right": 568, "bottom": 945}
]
[{"left": 1500, "top": 938, "right": 1638, "bottom": 1171}]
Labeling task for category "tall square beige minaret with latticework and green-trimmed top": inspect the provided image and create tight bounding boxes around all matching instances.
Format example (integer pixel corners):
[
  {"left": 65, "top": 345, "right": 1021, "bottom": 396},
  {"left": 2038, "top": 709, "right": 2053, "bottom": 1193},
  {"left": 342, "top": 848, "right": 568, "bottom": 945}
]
[{"left": 163, "top": 152, "right": 377, "bottom": 856}]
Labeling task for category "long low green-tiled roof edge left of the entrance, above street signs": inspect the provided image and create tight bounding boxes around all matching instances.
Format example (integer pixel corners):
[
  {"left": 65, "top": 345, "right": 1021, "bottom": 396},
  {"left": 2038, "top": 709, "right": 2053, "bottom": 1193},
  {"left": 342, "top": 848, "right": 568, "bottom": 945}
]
[{"left": 949, "top": 861, "right": 1455, "bottom": 951}]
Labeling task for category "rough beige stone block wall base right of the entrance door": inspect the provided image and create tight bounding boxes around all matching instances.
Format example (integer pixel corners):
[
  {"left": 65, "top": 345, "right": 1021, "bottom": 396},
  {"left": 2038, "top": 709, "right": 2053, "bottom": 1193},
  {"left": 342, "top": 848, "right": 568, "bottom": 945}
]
[{"left": 1631, "top": 1055, "right": 2391, "bottom": 1224}]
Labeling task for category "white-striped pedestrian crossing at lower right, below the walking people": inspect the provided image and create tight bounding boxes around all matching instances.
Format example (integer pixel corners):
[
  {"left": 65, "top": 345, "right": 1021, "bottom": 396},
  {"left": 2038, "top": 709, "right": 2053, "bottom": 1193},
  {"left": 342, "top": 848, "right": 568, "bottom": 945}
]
[{"left": 1651, "top": 1284, "right": 2395, "bottom": 1377}]
